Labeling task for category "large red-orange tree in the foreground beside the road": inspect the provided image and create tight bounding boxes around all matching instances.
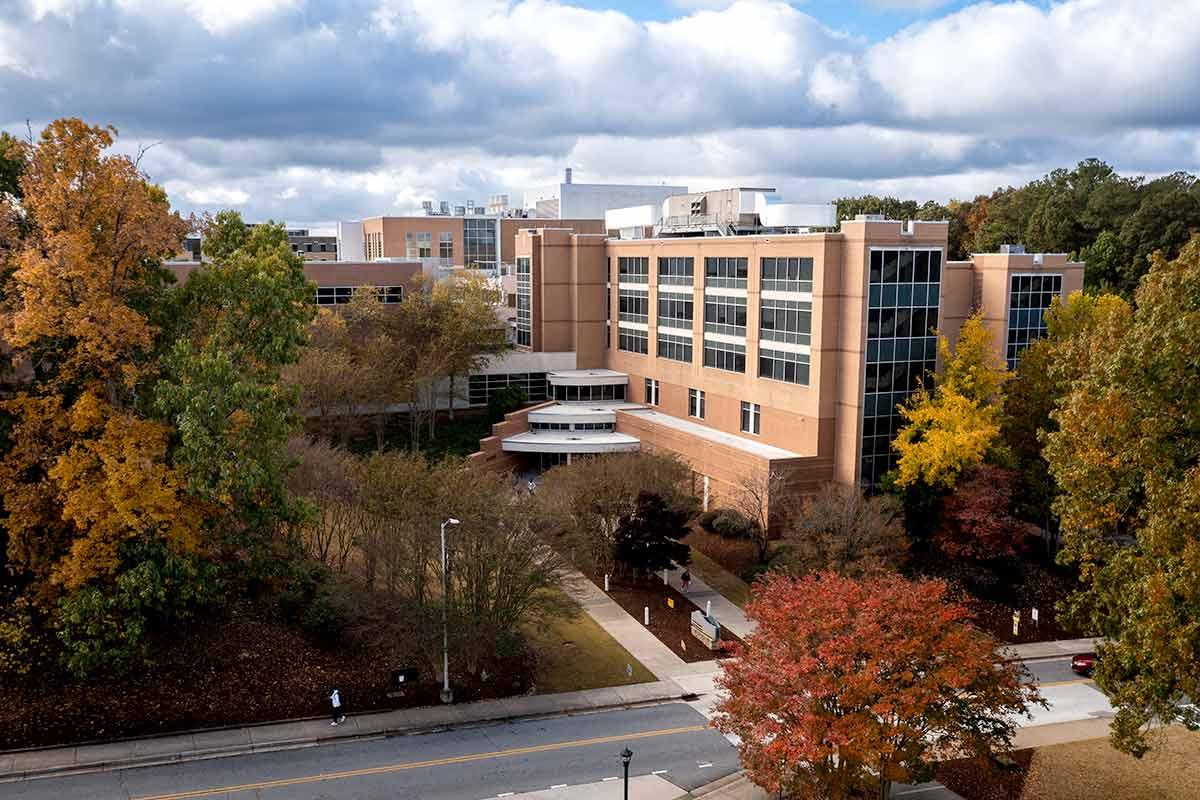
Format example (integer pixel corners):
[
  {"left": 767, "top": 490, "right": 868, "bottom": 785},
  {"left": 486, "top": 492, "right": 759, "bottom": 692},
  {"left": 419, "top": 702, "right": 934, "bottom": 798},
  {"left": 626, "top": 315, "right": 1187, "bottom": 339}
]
[{"left": 714, "top": 572, "right": 1043, "bottom": 800}]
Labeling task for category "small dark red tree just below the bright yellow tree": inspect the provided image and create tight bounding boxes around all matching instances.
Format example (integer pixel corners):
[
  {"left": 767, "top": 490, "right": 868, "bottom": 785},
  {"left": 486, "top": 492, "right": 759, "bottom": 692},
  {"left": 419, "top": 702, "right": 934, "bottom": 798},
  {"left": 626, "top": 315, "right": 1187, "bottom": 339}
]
[{"left": 935, "top": 464, "right": 1038, "bottom": 560}]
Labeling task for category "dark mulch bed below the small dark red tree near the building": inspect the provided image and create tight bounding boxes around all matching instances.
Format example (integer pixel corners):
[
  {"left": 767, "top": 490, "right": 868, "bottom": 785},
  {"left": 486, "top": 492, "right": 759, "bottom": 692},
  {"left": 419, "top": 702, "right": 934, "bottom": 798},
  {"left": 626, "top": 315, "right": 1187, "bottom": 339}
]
[{"left": 912, "top": 554, "right": 1087, "bottom": 644}]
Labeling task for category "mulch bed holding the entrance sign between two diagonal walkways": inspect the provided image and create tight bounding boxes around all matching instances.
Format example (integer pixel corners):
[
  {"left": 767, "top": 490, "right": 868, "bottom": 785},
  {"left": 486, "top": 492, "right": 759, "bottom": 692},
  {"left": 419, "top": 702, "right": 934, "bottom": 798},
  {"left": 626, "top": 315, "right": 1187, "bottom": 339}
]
[{"left": 588, "top": 575, "right": 742, "bottom": 662}]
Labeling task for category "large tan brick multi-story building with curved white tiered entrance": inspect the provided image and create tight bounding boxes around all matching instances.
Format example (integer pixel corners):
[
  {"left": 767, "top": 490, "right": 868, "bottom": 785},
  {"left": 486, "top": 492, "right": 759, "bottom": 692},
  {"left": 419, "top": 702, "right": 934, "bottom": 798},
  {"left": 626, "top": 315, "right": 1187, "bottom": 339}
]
[{"left": 474, "top": 201, "right": 1084, "bottom": 513}]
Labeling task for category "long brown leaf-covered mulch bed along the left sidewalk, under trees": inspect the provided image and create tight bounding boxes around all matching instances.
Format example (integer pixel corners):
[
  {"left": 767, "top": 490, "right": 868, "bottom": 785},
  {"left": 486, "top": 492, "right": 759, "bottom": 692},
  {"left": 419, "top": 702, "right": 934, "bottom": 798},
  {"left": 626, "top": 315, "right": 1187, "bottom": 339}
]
[{"left": 0, "top": 601, "right": 534, "bottom": 750}]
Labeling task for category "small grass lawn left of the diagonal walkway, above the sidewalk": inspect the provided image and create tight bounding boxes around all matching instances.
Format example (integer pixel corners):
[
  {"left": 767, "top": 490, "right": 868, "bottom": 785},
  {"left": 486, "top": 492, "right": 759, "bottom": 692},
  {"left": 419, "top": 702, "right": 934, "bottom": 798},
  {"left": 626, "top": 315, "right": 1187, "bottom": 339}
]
[{"left": 526, "top": 587, "right": 654, "bottom": 694}]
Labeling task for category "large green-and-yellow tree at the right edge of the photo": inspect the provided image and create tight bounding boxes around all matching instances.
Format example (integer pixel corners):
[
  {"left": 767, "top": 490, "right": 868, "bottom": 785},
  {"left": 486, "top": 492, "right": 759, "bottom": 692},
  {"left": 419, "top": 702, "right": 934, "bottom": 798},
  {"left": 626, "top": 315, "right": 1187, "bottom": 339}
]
[{"left": 1045, "top": 232, "right": 1200, "bottom": 754}]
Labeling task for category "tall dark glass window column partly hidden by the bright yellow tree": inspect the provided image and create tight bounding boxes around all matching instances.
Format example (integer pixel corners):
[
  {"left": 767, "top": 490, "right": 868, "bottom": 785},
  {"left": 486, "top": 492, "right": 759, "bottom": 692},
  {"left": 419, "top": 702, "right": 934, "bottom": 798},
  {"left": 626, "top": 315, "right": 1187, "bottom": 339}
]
[{"left": 859, "top": 248, "right": 942, "bottom": 486}]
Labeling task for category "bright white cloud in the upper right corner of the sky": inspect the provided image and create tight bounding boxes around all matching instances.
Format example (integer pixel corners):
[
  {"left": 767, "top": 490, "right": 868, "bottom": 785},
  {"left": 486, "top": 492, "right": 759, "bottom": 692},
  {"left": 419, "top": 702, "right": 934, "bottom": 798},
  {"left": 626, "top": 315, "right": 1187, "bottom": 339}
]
[{"left": 866, "top": 0, "right": 1200, "bottom": 131}]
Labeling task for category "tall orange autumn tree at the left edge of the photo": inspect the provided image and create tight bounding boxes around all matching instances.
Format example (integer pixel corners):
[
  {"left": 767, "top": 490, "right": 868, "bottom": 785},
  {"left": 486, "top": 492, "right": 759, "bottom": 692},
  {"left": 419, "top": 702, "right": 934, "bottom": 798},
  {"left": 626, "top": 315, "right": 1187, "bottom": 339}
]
[{"left": 0, "top": 119, "right": 199, "bottom": 594}]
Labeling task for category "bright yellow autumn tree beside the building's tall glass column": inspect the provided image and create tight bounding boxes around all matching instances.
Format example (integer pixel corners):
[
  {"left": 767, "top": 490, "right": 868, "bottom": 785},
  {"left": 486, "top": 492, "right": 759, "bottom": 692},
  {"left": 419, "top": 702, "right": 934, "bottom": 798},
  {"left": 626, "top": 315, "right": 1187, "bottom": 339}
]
[{"left": 893, "top": 312, "right": 1008, "bottom": 489}]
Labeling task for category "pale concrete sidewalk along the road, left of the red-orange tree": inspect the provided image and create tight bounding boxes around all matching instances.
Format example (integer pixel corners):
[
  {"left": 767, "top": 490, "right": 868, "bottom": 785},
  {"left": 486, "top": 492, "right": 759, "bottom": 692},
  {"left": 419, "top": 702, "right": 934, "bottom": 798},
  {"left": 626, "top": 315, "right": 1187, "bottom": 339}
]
[{"left": 0, "top": 681, "right": 683, "bottom": 783}]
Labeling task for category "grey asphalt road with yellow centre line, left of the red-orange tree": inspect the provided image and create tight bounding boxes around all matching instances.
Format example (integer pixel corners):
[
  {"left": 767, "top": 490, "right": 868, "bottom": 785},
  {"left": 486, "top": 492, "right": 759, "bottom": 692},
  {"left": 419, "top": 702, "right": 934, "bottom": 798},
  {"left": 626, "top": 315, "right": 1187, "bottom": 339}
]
[{"left": 7, "top": 703, "right": 738, "bottom": 800}]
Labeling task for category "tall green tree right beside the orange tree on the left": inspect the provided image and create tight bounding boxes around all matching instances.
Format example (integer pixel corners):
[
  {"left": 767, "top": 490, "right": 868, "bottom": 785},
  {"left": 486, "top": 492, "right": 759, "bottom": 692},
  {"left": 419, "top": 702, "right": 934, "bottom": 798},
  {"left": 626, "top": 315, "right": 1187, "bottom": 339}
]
[{"left": 155, "top": 215, "right": 313, "bottom": 548}]
